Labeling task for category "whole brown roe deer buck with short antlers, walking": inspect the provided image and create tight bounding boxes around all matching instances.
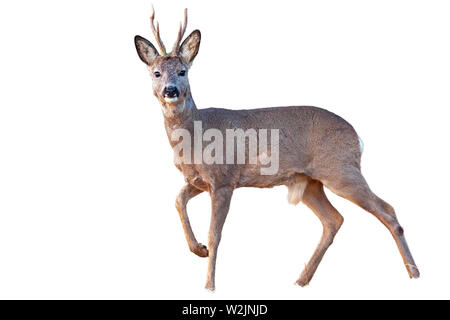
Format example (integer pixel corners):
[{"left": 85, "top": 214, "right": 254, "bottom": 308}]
[{"left": 134, "top": 8, "right": 420, "bottom": 291}]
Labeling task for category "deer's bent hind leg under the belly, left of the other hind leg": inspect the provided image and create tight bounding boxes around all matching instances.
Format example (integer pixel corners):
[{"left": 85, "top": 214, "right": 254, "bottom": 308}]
[{"left": 296, "top": 180, "right": 344, "bottom": 287}]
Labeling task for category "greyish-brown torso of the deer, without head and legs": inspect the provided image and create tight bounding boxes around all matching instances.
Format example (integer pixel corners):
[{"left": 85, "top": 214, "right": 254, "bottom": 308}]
[{"left": 165, "top": 100, "right": 361, "bottom": 191}]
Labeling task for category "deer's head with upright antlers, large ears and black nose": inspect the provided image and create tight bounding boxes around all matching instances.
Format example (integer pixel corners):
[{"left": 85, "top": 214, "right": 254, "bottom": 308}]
[{"left": 134, "top": 9, "right": 201, "bottom": 113}]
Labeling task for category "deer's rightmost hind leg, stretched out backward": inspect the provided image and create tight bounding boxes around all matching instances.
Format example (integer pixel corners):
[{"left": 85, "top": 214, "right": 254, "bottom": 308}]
[{"left": 322, "top": 167, "right": 420, "bottom": 278}]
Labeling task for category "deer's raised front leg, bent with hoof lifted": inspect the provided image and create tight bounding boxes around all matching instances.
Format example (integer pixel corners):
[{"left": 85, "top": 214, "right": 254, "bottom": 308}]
[{"left": 176, "top": 183, "right": 208, "bottom": 258}]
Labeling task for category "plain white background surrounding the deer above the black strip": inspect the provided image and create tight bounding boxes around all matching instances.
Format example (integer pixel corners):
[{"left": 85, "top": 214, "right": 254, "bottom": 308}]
[{"left": 0, "top": 0, "right": 450, "bottom": 299}]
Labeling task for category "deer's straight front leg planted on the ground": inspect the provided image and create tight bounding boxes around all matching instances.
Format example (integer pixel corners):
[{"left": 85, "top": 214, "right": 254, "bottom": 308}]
[{"left": 205, "top": 187, "right": 233, "bottom": 291}]
